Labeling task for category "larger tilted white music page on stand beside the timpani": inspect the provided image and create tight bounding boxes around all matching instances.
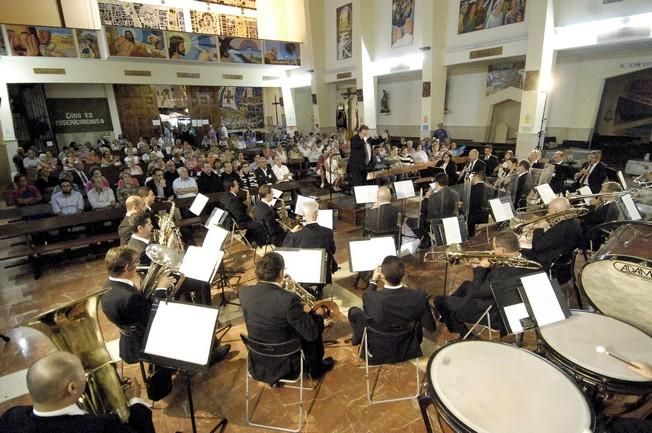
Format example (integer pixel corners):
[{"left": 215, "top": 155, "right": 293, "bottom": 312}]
[{"left": 521, "top": 272, "right": 566, "bottom": 327}]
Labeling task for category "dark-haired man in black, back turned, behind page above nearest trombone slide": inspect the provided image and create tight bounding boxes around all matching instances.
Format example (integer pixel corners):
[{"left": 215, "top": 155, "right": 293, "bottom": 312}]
[{"left": 419, "top": 173, "right": 459, "bottom": 243}]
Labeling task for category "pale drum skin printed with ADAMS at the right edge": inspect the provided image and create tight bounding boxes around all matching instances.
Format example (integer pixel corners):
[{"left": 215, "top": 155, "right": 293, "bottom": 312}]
[{"left": 580, "top": 257, "right": 652, "bottom": 335}]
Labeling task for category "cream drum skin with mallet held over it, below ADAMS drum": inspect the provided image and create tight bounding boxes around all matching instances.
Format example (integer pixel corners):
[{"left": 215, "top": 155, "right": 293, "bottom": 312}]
[{"left": 539, "top": 311, "right": 652, "bottom": 382}]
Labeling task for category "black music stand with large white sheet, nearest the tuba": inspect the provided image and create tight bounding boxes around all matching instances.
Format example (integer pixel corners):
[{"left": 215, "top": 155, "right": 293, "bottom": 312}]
[{"left": 141, "top": 302, "right": 228, "bottom": 433}]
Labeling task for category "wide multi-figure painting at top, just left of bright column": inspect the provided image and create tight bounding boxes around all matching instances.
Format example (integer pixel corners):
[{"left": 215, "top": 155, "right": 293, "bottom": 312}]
[{"left": 457, "top": 0, "right": 526, "bottom": 33}]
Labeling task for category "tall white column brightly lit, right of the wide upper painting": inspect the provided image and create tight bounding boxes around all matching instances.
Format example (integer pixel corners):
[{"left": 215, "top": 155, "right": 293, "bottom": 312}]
[{"left": 516, "top": 0, "right": 555, "bottom": 159}]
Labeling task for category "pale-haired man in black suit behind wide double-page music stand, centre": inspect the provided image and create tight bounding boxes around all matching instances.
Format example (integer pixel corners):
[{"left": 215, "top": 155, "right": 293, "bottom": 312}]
[{"left": 283, "top": 201, "right": 337, "bottom": 284}]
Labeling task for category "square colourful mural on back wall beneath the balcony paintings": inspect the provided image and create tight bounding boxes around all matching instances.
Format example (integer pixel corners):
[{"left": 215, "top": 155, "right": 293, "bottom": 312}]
[{"left": 218, "top": 86, "right": 265, "bottom": 130}]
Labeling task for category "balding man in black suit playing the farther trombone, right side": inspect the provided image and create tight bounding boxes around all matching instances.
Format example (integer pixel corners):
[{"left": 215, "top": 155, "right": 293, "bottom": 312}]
[{"left": 524, "top": 197, "right": 582, "bottom": 269}]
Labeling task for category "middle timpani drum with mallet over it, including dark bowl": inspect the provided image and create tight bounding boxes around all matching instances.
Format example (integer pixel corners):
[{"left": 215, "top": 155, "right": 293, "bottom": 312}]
[{"left": 539, "top": 310, "right": 652, "bottom": 415}]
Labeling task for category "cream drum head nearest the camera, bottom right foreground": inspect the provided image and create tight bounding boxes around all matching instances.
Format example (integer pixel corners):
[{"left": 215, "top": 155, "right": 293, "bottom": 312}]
[{"left": 427, "top": 341, "right": 593, "bottom": 433}]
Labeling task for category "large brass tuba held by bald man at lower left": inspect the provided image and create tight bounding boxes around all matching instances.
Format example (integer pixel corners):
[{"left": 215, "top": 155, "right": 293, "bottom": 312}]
[{"left": 20, "top": 290, "right": 129, "bottom": 422}]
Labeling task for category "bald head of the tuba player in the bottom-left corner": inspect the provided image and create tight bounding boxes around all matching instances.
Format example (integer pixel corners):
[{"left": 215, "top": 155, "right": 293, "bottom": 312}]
[{"left": 27, "top": 352, "right": 86, "bottom": 407}]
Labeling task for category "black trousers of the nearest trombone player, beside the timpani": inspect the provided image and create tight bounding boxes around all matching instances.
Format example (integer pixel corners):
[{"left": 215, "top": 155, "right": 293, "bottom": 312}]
[{"left": 435, "top": 281, "right": 493, "bottom": 336}]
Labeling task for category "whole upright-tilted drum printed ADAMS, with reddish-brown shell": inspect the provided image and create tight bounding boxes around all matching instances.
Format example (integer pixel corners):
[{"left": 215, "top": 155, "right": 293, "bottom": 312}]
[{"left": 579, "top": 222, "right": 652, "bottom": 335}]
